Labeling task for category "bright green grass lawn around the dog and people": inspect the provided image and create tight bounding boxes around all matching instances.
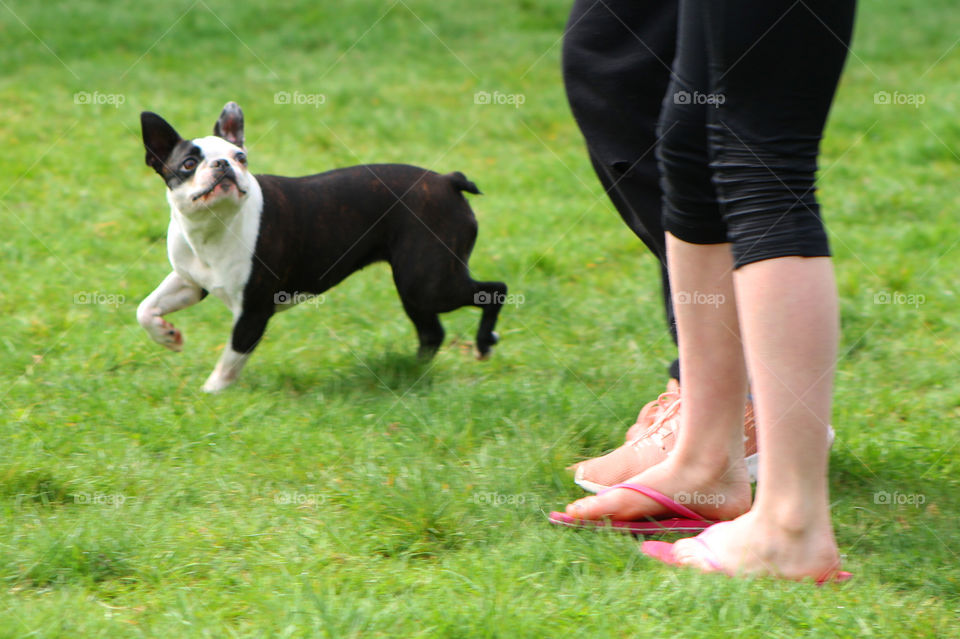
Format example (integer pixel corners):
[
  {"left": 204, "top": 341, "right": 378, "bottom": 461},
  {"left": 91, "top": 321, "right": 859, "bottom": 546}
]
[{"left": 0, "top": 0, "right": 960, "bottom": 638}]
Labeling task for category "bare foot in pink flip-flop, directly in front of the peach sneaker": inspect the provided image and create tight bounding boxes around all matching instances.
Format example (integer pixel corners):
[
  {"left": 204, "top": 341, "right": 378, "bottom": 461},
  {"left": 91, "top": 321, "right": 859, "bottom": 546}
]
[{"left": 566, "top": 457, "right": 751, "bottom": 521}]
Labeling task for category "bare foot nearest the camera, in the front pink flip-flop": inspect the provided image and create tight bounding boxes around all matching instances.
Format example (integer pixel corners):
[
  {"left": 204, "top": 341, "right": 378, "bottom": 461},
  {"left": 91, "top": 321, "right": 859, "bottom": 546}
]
[{"left": 673, "top": 511, "right": 840, "bottom": 581}]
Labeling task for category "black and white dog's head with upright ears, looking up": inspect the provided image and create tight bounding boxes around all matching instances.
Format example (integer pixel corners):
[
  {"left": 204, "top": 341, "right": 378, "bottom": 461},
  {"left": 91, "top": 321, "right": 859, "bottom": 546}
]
[{"left": 140, "top": 102, "right": 254, "bottom": 216}]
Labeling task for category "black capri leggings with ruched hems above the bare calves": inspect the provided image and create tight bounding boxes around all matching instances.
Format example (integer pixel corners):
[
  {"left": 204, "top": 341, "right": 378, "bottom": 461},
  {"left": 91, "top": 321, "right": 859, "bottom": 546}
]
[{"left": 658, "top": 0, "right": 856, "bottom": 268}]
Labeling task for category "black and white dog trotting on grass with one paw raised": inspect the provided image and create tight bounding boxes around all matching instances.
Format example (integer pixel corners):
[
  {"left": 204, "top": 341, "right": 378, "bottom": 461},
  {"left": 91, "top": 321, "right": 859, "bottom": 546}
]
[{"left": 137, "top": 102, "right": 507, "bottom": 392}]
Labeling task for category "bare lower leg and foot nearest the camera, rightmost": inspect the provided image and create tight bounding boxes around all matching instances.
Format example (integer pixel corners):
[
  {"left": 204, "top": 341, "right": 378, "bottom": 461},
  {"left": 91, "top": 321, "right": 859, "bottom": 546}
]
[{"left": 674, "top": 257, "right": 839, "bottom": 579}]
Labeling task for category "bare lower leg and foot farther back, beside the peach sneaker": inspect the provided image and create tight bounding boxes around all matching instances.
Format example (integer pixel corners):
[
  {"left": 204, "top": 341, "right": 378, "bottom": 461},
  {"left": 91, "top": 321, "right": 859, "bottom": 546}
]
[{"left": 566, "top": 234, "right": 752, "bottom": 520}]
